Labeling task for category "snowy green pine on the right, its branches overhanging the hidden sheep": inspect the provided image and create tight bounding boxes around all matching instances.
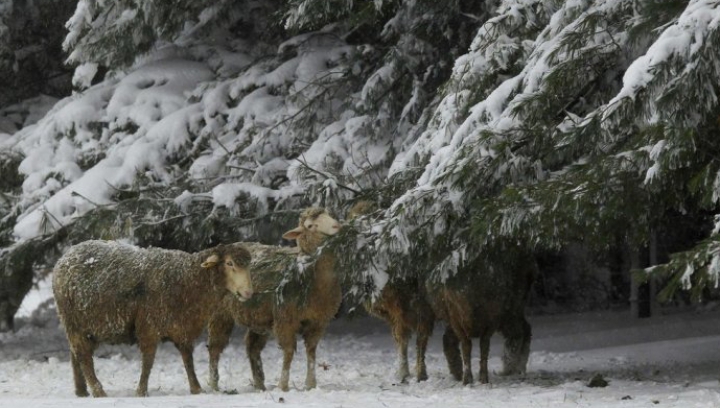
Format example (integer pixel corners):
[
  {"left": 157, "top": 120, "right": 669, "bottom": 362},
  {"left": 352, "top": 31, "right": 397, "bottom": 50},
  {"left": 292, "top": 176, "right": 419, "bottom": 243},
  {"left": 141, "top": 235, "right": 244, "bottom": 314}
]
[{"left": 377, "top": 1, "right": 720, "bottom": 300}]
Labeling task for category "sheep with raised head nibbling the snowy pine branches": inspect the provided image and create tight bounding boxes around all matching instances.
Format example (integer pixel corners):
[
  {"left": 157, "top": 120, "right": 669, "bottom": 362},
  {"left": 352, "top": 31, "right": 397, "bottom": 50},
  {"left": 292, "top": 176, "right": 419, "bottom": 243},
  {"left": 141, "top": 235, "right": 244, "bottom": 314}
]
[{"left": 208, "top": 208, "right": 342, "bottom": 391}]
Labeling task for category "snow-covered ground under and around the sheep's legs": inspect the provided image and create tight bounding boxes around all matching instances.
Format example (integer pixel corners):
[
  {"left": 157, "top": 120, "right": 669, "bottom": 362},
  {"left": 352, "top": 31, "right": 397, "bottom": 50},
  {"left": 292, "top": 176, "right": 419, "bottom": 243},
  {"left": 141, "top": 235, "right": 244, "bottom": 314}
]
[{"left": 0, "top": 311, "right": 720, "bottom": 408}]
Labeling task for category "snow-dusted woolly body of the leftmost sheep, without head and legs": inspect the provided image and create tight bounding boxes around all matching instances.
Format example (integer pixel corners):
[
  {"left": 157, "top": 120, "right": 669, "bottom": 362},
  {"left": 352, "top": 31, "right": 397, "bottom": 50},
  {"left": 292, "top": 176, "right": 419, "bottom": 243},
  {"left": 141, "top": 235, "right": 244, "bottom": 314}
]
[{"left": 53, "top": 241, "right": 235, "bottom": 344}]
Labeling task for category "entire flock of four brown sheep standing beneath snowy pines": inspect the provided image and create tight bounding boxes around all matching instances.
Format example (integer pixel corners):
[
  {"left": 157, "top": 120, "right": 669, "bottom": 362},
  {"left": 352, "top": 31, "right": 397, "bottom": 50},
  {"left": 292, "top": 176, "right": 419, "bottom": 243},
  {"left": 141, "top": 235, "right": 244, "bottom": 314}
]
[{"left": 53, "top": 206, "right": 536, "bottom": 397}]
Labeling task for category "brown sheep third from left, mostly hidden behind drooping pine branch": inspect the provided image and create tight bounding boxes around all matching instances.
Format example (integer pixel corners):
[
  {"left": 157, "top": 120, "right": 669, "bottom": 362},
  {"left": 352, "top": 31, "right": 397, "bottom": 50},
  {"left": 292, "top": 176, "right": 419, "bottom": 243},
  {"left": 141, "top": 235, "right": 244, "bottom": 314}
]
[{"left": 346, "top": 200, "right": 460, "bottom": 383}]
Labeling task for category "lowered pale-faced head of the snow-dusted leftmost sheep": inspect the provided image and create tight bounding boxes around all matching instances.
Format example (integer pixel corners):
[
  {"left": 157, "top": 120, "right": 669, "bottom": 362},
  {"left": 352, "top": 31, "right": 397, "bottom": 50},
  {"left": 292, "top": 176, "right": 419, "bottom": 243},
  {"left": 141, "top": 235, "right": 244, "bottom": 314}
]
[{"left": 202, "top": 244, "right": 253, "bottom": 302}]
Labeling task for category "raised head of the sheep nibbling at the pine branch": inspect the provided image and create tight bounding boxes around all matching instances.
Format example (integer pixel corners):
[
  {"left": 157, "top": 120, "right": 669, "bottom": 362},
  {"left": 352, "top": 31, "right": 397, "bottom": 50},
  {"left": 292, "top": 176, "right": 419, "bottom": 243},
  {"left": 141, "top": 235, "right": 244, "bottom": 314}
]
[{"left": 283, "top": 207, "right": 340, "bottom": 254}]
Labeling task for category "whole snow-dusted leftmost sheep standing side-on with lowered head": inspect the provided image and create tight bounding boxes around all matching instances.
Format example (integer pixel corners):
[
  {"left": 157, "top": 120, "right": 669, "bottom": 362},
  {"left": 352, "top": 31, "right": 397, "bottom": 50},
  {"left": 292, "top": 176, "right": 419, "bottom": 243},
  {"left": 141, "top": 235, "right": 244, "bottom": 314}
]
[{"left": 53, "top": 241, "right": 253, "bottom": 397}]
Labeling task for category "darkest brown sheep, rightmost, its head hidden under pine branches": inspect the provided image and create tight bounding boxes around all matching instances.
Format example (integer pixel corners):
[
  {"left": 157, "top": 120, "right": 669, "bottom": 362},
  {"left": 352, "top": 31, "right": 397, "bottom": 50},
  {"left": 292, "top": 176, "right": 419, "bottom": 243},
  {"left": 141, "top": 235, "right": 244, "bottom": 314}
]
[{"left": 426, "top": 244, "right": 537, "bottom": 384}]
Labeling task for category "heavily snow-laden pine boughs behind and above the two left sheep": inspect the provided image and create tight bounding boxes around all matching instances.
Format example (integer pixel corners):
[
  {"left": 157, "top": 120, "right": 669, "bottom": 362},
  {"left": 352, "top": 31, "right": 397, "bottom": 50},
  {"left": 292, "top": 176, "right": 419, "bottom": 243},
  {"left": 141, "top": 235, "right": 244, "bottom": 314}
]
[{"left": 0, "top": 0, "right": 486, "bottom": 326}]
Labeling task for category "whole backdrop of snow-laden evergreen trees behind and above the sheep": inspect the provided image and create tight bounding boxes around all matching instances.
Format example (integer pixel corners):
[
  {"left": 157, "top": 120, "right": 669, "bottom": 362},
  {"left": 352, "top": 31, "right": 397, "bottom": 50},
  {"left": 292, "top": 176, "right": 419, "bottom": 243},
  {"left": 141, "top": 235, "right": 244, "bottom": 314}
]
[{"left": 0, "top": 0, "right": 720, "bottom": 330}]
